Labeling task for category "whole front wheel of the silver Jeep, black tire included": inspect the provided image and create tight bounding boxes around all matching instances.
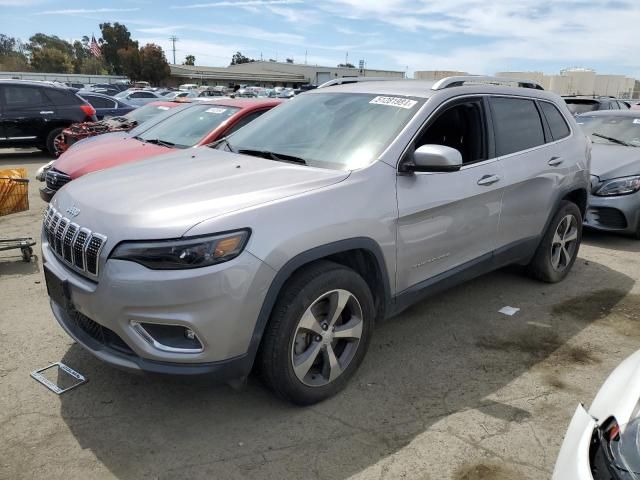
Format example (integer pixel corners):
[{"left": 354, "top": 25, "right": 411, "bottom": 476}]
[{"left": 259, "top": 261, "right": 375, "bottom": 405}]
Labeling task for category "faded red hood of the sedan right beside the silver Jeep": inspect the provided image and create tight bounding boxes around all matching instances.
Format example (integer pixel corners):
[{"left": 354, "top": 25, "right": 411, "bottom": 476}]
[{"left": 54, "top": 135, "right": 174, "bottom": 179}]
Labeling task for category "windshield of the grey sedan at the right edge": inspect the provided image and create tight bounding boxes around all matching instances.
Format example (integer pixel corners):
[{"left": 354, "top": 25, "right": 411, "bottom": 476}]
[{"left": 576, "top": 112, "right": 640, "bottom": 147}]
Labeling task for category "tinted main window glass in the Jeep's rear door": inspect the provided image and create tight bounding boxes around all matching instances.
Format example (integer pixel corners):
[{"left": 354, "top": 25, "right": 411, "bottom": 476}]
[{"left": 490, "top": 97, "right": 545, "bottom": 157}]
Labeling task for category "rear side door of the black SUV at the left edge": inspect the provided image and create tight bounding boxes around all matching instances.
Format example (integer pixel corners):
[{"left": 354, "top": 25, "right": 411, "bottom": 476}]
[{"left": 1, "top": 85, "right": 55, "bottom": 145}]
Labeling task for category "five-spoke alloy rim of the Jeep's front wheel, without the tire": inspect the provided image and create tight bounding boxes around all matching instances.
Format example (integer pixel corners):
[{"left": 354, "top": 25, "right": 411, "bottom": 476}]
[{"left": 291, "top": 290, "right": 363, "bottom": 387}]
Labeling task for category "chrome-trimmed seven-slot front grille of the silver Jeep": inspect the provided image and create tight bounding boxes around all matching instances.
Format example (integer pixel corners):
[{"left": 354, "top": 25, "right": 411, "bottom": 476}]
[{"left": 44, "top": 205, "right": 107, "bottom": 277}]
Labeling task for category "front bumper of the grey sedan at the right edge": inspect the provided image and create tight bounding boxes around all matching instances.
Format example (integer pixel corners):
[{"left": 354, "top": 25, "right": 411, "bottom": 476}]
[{"left": 584, "top": 192, "right": 640, "bottom": 235}]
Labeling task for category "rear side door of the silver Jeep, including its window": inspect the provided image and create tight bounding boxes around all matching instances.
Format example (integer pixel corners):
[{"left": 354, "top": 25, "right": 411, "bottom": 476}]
[{"left": 489, "top": 96, "right": 571, "bottom": 254}]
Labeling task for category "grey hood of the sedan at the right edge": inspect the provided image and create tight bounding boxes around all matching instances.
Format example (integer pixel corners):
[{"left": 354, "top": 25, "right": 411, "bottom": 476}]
[{"left": 591, "top": 143, "right": 640, "bottom": 181}]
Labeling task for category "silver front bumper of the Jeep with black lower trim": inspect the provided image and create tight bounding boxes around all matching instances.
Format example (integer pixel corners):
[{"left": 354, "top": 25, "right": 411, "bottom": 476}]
[{"left": 42, "top": 231, "right": 275, "bottom": 380}]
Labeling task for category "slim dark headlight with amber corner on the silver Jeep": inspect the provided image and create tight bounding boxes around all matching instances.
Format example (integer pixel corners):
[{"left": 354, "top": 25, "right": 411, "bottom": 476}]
[{"left": 111, "top": 230, "right": 250, "bottom": 270}]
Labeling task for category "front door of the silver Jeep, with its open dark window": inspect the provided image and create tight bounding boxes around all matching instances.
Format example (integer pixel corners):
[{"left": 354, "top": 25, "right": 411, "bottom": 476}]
[{"left": 397, "top": 97, "right": 504, "bottom": 292}]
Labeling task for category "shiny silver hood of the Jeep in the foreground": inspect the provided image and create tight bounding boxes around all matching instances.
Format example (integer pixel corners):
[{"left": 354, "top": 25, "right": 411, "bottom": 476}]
[{"left": 51, "top": 147, "right": 349, "bottom": 240}]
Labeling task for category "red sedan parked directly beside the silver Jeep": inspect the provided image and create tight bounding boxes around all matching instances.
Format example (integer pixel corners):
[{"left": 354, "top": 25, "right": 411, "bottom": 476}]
[{"left": 40, "top": 99, "right": 282, "bottom": 202}]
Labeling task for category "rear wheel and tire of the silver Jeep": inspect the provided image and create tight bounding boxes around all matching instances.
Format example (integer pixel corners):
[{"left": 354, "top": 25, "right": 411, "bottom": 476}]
[{"left": 528, "top": 200, "right": 582, "bottom": 283}]
